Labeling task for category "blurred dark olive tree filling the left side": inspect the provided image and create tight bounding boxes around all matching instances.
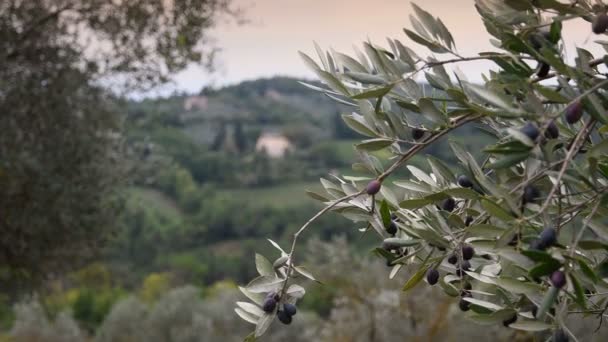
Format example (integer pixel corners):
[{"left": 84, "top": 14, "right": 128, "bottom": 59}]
[{"left": 0, "top": 0, "right": 237, "bottom": 290}]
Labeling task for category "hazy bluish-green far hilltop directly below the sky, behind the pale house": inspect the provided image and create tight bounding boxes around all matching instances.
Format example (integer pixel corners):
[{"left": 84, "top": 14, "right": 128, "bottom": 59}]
[{"left": 129, "top": 77, "right": 346, "bottom": 143}]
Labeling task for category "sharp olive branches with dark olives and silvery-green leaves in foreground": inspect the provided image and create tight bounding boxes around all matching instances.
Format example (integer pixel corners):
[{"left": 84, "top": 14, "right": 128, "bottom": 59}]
[{"left": 236, "top": 0, "right": 608, "bottom": 341}]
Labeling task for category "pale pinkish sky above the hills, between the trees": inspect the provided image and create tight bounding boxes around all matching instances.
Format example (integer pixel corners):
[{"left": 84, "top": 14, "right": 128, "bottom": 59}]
[{"left": 165, "top": 0, "right": 600, "bottom": 92}]
